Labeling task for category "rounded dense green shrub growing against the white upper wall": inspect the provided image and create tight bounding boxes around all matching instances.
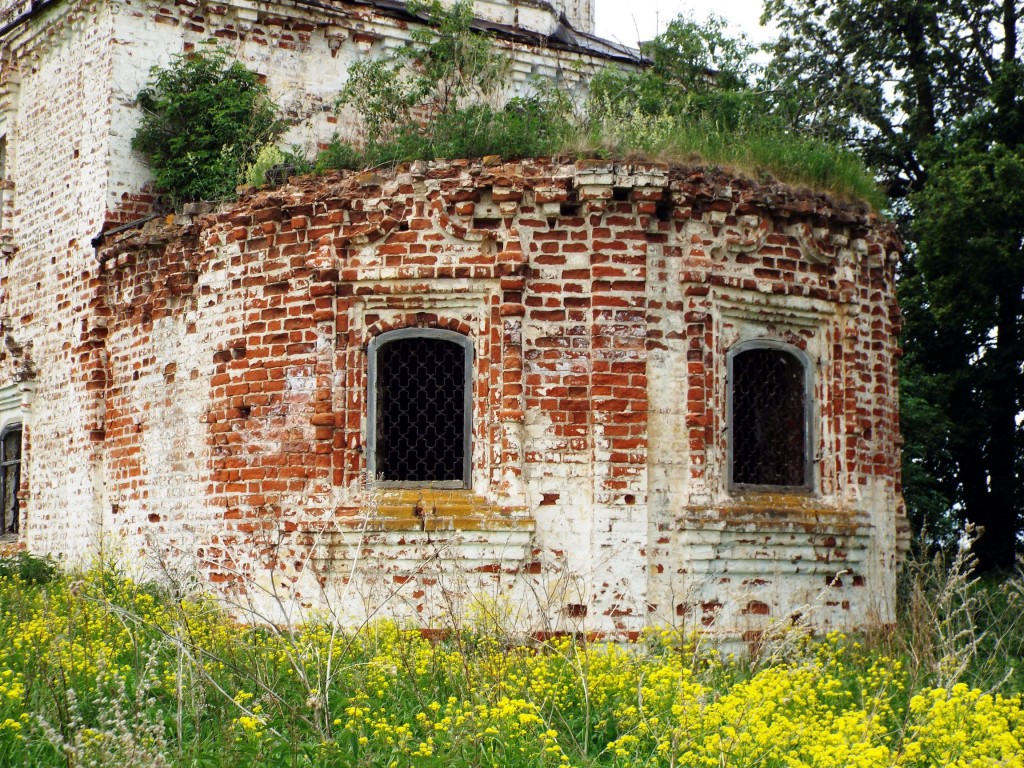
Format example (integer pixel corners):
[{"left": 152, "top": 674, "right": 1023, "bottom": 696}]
[{"left": 132, "top": 48, "right": 285, "bottom": 204}]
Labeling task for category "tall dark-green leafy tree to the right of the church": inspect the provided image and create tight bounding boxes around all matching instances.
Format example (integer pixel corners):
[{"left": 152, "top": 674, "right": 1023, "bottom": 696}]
[{"left": 766, "top": 0, "right": 1024, "bottom": 567}]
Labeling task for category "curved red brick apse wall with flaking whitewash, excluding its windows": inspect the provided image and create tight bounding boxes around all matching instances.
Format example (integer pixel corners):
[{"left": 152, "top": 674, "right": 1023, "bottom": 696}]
[{"left": 64, "top": 161, "right": 900, "bottom": 635}]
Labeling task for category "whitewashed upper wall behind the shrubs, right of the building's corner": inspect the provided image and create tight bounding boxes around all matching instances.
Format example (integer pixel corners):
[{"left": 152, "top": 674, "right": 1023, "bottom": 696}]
[{"left": 108, "top": 0, "right": 622, "bottom": 214}]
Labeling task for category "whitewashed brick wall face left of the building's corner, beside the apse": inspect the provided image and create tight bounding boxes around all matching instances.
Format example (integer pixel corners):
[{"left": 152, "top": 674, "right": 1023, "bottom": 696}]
[{"left": 0, "top": 5, "right": 112, "bottom": 559}]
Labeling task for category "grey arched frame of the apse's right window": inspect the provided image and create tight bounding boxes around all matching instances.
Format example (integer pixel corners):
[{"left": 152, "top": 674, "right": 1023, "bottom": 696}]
[{"left": 725, "top": 339, "right": 816, "bottom": 494}]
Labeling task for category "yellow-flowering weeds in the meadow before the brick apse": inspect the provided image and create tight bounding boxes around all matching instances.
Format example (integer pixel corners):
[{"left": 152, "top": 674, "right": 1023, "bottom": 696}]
[{"left": 6, "top": 561, "right": 1024, "bottom": 768}]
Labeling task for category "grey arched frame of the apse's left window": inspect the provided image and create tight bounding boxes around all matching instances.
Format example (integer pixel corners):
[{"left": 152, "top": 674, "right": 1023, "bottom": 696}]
[{"left": 366, "top": 328, "right": 474, "bottom": 489}]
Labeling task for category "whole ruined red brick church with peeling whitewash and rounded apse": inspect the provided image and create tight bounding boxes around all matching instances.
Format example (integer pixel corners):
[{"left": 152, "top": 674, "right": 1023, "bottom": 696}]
[{"left": 0, "top": 0, "right": 905, "bottom": 638}]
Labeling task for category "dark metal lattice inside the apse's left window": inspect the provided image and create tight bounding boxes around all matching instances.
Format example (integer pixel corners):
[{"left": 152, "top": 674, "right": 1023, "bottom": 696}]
[{"left": 376, "top": 337, "right": 466, "bottom": 482}]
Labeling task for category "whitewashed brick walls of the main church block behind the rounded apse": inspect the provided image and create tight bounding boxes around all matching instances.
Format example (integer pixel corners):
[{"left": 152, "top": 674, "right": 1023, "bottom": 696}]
[{"left": 0, "top": 0, "right": 631, "bottom": 558}]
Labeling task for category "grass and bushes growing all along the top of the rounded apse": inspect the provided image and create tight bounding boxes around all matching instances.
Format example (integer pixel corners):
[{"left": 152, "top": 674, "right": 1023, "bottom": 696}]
[{"left": 132, "top": 0, "right": 881, "bottom": 207}]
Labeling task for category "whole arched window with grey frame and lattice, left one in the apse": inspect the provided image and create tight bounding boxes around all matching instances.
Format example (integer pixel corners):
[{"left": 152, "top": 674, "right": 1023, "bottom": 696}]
[{"left": 367, "top": 328, "right": 473, "bottom": 488}]
